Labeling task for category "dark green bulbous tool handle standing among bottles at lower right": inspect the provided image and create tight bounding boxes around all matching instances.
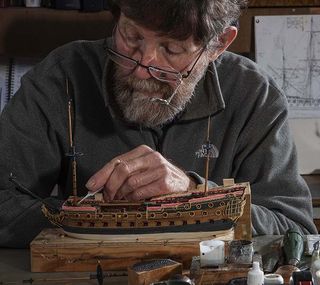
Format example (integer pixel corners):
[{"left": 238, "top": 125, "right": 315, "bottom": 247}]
[{"left": 283, "top": 229, "right": 304, "bottom": 266}]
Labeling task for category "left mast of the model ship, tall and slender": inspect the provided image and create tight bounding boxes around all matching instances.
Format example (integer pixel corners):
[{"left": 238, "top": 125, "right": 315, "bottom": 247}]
[{"left": 66, "top": 78, "right": 82, "bottom": 205}]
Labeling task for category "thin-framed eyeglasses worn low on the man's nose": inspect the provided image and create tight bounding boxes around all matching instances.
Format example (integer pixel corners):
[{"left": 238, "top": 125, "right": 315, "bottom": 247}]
[{"left": 107, "top": 47, "right": 204, "bottom": 83}]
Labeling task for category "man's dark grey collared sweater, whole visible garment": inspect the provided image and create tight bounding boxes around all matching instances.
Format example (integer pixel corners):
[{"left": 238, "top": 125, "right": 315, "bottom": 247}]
[{"left": 0, "top": 40, "right": 316, "bottom": 247}]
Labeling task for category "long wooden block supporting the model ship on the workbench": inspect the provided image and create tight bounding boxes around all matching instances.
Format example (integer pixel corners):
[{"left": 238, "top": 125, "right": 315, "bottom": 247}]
[{"left": 30, "top": 229, "right": 234, "bottom": 272}]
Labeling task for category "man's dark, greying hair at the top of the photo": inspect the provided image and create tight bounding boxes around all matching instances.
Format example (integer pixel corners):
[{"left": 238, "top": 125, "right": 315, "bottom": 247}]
[{"left": 110, "top": 0, "right": 247, "bottom": 46}]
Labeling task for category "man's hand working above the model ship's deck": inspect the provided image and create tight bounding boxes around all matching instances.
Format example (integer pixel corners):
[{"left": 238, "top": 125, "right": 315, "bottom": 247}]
[{"left": 86, "top": 145, "right": 194, "bottom": 201}]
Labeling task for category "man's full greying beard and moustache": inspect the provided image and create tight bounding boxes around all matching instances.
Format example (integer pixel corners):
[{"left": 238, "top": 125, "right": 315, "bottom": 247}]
[{"left": 113, "top": 62, "right": 205, "bottom": 128}]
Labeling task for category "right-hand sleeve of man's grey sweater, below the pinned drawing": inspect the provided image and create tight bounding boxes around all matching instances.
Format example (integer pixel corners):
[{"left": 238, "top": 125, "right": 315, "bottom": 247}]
[{"left": 233, "top": 84, "right": 317, "bottom": 235}]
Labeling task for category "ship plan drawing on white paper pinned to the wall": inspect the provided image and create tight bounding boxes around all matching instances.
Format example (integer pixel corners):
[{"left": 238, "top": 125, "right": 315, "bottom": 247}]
[{"left": 254, "top": 15, "right": 320, "bottom": 118}]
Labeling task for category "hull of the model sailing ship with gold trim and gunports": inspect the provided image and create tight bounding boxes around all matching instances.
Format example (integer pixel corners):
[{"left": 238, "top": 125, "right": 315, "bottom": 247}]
[{"left": 43, "top": 183, "right": 249, "bottom": 239}]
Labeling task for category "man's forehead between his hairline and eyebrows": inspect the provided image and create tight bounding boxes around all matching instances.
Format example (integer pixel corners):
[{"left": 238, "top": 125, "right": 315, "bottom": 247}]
[{"left": 119, "top": 13, "right": 201, "bottom": 50}]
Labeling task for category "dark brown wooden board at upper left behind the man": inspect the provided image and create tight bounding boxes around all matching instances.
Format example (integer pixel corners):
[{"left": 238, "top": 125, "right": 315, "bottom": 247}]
[{"left": 0, "top": 7, "right": 113, "bottom": 57}]
